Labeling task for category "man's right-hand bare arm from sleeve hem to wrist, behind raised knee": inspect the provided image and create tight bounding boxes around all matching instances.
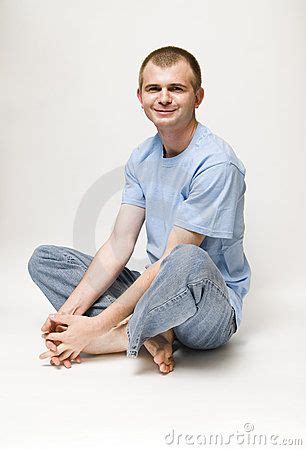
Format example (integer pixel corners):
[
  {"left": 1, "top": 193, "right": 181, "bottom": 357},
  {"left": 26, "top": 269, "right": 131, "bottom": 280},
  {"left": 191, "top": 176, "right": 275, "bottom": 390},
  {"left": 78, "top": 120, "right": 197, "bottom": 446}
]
[{"left": 93, "top": 226, "right": 205, "bottom": 333}]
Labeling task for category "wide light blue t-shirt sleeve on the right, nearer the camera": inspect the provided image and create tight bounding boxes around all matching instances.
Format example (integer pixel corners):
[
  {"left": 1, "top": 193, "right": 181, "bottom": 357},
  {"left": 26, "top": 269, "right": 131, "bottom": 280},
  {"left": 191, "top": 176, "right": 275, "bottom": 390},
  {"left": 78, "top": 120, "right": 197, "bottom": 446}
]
[{"left": 173, "top": 162, "right": 244, "bottom": 239}]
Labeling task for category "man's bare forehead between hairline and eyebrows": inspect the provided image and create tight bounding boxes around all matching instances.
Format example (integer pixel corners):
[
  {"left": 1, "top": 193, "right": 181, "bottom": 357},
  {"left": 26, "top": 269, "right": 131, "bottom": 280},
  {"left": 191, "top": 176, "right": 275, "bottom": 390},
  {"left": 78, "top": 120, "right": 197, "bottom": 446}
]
[{"left": 143, "top": 60, "right": 193, "bottom": 86}]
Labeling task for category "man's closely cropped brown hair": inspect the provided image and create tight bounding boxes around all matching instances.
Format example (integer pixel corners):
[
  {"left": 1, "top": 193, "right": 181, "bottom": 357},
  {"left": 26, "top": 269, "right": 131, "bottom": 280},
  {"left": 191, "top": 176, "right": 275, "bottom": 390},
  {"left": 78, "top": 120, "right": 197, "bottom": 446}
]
[{"left": 138, "top": 45, "right": 202, "bottom": 92}]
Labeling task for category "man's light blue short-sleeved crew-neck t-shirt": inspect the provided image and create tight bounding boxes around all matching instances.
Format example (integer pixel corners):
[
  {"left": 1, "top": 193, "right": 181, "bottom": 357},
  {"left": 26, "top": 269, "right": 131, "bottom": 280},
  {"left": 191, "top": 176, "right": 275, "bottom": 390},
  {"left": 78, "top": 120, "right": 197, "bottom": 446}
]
[{"left": 121, "top": 122, "right": 251, "bottom": 328}]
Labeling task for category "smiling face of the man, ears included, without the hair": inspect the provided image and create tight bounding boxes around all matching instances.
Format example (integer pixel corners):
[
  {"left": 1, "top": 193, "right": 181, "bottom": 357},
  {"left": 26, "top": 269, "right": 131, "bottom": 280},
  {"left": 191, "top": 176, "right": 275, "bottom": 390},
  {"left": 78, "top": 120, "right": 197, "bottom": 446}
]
[{"left": 137, "top": 60, "right": 204, "bottom": 129}]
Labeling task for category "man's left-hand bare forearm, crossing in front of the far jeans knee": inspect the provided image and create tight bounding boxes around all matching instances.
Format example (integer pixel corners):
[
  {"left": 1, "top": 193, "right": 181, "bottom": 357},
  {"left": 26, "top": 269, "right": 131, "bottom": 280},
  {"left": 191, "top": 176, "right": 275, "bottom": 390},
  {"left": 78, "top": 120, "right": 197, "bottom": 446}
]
[{"left": 59, "top": 238, "right": 133, "bottom": 315}]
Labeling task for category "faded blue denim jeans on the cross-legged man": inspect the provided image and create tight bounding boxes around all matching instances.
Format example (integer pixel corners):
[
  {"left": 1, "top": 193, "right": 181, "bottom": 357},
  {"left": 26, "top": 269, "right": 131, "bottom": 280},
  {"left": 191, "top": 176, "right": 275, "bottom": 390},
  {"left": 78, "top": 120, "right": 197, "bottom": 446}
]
[{"left": 28, "top": 244, "right": 236, "bottom": 357}]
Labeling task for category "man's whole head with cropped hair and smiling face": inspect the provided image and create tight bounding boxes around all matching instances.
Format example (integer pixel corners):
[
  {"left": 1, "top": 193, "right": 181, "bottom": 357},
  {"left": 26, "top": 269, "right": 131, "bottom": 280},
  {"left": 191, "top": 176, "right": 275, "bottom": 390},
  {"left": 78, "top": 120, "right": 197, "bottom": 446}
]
[{"left": 137, "top": 47, "right": 204, "bottom": 129}]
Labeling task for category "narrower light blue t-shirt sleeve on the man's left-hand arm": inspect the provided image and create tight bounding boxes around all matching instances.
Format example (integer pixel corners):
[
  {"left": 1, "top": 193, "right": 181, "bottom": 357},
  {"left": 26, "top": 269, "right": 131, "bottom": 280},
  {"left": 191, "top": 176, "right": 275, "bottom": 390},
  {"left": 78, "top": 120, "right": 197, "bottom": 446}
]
[{"left": 121, "top": 152, "right": 146, "bottom": 208}]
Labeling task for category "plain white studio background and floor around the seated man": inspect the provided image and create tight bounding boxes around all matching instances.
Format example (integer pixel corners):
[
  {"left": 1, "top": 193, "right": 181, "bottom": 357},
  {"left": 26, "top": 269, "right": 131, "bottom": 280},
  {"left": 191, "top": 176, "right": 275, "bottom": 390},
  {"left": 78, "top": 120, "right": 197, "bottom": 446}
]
[{"left": 0, "top": 0, "right": 306, "bottom": 450}]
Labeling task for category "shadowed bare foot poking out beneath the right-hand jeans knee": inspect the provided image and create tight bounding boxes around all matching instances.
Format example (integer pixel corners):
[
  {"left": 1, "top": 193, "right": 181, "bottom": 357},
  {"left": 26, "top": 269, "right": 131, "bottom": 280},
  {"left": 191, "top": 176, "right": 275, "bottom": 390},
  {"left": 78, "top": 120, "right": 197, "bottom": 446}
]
[{"left": 144, "top": 329, "right": 174, "bottom": 374}]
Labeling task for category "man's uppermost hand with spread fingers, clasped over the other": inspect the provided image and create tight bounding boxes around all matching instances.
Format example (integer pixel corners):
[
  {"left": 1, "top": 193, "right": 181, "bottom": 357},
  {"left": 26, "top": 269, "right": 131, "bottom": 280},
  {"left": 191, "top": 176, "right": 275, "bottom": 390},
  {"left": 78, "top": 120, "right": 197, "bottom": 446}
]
[{"left": 40, "top": 314, "right": 98, "bottom": 361}]
